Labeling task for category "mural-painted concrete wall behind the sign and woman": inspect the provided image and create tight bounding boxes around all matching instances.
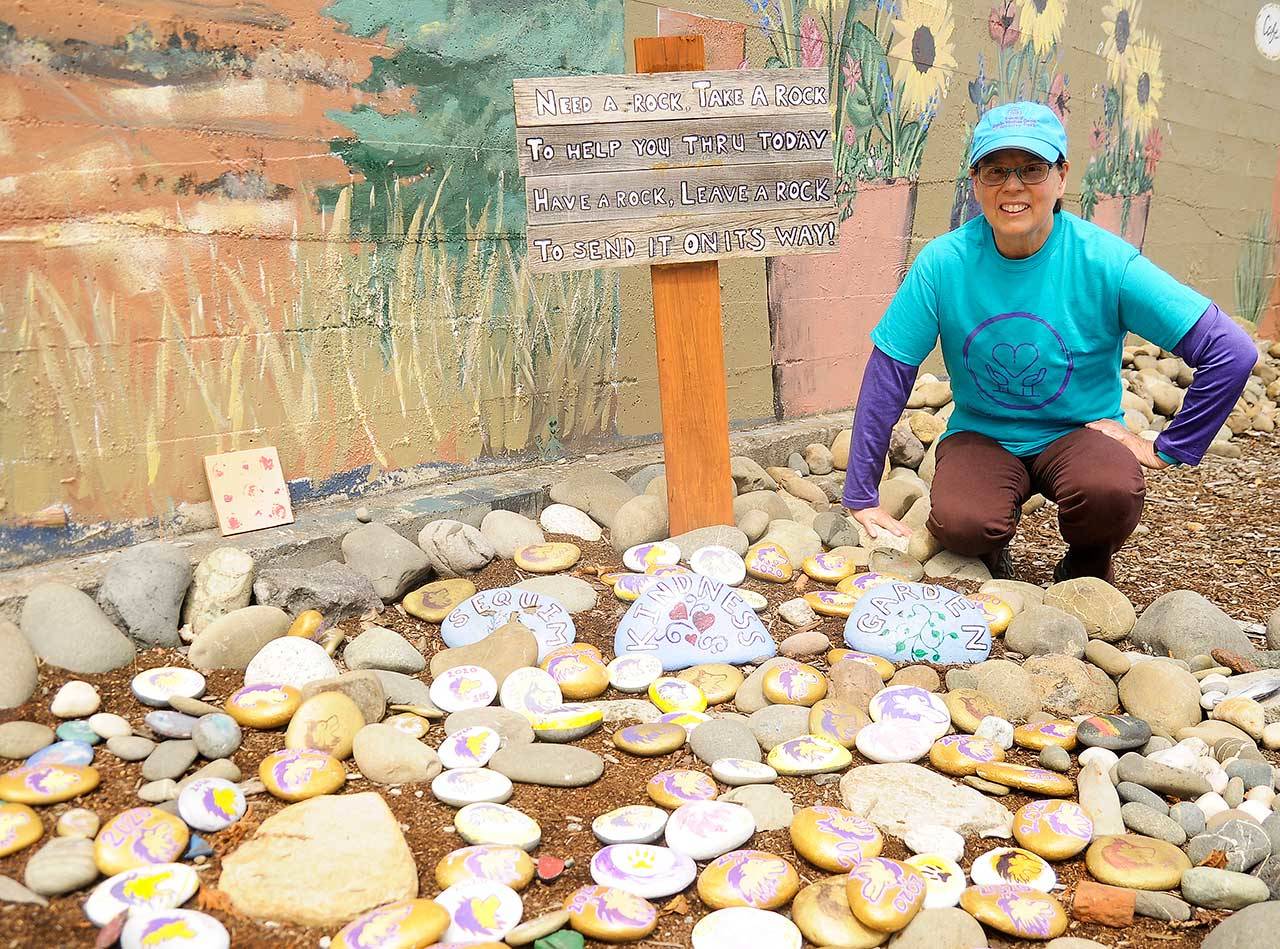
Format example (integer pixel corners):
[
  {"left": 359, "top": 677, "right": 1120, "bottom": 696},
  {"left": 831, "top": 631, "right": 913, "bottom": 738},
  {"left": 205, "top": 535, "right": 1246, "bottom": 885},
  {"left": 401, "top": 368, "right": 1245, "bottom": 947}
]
[{"left": 0, "top": 0, "right": 1280, "bottom": 566}]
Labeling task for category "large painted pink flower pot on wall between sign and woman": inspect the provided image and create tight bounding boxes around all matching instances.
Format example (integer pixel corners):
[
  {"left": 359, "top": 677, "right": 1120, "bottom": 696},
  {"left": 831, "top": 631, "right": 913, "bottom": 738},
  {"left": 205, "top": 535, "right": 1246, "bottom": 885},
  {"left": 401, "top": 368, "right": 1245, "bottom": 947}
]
[{"left": 768, "top": 178, "right": 915, "bottom": 418}]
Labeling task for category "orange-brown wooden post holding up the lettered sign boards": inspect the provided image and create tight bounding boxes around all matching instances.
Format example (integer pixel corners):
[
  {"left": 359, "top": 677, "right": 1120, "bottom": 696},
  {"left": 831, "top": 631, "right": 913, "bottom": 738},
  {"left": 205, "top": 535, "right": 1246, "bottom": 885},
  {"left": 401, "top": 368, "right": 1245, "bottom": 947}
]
[{"left": 635, "top": 36, "right": 733, "bottom": 535}]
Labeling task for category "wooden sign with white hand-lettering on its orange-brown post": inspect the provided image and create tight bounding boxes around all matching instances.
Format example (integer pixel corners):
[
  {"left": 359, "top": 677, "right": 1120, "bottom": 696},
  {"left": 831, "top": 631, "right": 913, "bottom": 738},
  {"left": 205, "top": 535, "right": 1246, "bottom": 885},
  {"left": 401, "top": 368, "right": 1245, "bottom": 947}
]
[{"left": 513, "top": 44, "right": 837, "bottom": 534}]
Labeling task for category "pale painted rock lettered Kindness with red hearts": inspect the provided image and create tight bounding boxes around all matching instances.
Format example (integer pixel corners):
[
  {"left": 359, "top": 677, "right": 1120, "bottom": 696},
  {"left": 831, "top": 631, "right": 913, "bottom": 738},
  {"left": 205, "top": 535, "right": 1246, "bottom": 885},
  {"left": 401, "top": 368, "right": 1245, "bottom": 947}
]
[{"left": 613, "top": 575, "right": 777, "bottom": 671}]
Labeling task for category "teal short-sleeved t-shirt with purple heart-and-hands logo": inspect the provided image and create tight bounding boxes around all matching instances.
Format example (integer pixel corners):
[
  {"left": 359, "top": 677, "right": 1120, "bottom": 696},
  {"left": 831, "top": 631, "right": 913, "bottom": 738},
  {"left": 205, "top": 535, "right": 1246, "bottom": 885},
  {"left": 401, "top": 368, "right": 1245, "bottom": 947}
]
[{"left": 872, "top": 211, "right": 1210, "bottom": 456}]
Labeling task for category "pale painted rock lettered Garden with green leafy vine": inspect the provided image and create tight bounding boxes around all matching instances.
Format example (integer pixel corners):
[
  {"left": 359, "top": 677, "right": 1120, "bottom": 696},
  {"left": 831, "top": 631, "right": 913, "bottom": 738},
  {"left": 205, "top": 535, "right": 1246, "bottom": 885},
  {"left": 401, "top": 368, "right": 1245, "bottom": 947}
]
[{"left": 845, "top": 580, "right": 991, "bottom": 665}]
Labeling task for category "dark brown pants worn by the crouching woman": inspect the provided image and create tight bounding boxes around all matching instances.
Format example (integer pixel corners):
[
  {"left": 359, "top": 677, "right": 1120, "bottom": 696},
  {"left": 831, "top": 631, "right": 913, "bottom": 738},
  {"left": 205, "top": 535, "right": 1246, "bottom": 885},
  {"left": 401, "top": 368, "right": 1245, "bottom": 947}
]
[{"left": 928, "top": 428, "right": 1147, "bottom": 583}]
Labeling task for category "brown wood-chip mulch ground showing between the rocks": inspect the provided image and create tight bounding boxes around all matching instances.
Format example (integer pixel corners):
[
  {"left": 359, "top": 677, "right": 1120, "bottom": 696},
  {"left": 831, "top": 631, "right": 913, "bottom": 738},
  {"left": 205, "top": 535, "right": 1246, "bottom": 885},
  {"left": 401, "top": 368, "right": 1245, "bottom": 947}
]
[{"left": 0, "top": 435, "right": 1280, "bottom": 949}]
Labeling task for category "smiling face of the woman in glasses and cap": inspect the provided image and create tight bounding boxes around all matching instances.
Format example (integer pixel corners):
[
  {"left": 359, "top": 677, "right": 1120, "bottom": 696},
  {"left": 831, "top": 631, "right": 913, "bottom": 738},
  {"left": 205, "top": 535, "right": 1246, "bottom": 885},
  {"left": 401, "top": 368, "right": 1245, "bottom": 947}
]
[{"left": 969, "top": 149, "right": 1070, "bottom": 257}]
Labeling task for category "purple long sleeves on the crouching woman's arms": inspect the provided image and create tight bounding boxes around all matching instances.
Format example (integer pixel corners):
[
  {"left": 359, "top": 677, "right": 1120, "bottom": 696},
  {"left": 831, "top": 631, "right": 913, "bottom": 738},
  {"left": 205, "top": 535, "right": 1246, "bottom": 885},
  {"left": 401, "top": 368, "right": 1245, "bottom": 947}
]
[{"left": 844, "top": 304, "right": 1258, "bottom": 511}]
